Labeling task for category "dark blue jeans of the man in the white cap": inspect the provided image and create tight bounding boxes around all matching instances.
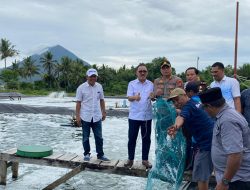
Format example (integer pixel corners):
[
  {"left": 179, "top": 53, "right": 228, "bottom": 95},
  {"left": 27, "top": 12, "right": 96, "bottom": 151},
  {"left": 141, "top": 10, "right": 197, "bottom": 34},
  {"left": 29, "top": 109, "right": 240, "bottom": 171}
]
[{"left": 82, "top": 119, "right": 104, "bottom": 158}]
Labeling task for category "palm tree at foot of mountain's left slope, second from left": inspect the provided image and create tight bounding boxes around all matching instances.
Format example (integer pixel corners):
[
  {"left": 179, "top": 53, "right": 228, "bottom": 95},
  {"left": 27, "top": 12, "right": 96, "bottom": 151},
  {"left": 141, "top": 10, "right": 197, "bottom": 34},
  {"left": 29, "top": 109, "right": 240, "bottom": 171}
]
[{"left": 22, "top": 56, "right": 39, "bottom": 79}]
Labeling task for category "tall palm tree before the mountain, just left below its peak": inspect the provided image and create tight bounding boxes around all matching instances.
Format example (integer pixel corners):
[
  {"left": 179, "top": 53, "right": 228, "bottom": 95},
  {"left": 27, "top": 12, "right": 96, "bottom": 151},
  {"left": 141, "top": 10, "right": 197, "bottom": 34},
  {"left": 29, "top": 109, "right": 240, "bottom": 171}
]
[{"left": 40, "top": 51, "right": 57, "bottom": 88}]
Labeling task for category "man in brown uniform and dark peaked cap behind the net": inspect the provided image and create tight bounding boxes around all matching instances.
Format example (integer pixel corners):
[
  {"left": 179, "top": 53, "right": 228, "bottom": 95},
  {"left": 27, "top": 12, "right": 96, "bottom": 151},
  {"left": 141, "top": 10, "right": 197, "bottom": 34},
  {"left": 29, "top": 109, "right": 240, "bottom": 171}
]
[{"left": 154, "top": 58, "right": 183, "bottom": 99}]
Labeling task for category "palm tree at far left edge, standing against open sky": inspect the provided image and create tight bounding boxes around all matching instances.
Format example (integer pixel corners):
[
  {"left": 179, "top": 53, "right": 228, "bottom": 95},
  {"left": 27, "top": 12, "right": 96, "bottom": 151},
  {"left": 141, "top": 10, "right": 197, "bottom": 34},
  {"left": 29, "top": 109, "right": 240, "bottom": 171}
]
[{"left": 0, "top": 38, "right": 18, "bottom": 68}]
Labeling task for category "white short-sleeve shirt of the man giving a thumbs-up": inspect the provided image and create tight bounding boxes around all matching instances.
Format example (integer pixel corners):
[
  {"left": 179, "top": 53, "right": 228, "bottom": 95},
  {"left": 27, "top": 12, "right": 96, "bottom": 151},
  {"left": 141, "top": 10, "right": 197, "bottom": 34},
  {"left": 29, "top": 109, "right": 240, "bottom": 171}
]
[{"left": 127, "top": 79, "right": 154, "bottom": 121}]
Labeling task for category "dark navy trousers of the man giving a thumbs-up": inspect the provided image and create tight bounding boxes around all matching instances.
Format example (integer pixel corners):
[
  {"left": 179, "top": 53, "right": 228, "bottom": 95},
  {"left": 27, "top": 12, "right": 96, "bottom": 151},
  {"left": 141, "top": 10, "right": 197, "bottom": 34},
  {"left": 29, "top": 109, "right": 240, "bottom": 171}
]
[{"left": 128, "top": 119, "right": 152, "bottom": 160}]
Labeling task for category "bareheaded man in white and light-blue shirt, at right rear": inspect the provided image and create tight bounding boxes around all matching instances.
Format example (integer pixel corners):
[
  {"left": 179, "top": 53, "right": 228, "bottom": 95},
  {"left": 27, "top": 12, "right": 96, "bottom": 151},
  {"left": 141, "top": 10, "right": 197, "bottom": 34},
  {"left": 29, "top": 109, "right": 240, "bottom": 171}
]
[{"left": 210, "top": 62, "right": 241, "bottom": 113}]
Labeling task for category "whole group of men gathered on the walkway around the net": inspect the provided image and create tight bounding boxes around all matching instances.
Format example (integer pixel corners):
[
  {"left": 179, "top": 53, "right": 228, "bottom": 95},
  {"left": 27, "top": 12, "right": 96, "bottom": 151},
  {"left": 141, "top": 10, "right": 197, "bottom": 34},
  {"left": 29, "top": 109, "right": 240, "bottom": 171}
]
[{"left": 76, "top": 59, "right": 250, "bottom": 190}]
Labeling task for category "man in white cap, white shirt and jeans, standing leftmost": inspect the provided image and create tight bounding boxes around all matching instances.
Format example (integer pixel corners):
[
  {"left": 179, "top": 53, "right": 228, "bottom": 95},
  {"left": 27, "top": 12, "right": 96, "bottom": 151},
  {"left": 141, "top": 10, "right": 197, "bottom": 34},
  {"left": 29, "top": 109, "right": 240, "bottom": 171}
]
[{"left": 76, "top": 69, "right": 109, "bottom": 161}]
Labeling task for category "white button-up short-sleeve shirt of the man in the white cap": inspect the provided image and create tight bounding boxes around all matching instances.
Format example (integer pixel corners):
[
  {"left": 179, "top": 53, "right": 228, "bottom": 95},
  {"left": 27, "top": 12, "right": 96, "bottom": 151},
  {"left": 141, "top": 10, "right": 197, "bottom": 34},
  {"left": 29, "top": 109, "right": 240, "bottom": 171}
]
[{"left": 76, "top": 82, "right": 104, "bottom": 122}]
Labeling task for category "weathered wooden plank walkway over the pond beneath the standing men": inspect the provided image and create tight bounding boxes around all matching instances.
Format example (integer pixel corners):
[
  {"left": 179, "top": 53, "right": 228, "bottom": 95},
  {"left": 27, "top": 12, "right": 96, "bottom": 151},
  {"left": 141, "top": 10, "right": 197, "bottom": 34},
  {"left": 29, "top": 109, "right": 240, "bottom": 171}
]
[{"left": 0, "top": 148, "right": 204, "bottom": 190}]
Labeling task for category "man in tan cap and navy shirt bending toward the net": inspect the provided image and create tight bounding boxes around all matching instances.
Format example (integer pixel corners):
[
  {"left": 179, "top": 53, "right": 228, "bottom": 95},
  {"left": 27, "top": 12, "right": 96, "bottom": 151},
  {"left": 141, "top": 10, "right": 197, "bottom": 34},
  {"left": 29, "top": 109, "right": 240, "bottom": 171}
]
[{"left": 167, "top": 88, "right": 214, "bottom": 190}]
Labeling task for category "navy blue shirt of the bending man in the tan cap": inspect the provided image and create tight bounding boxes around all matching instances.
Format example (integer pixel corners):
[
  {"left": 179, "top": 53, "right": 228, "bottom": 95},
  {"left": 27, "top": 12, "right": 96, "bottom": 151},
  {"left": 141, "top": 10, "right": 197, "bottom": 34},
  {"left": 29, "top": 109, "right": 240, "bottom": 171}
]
[{"left": 180, "top": 99, "right": 214, "bottom": 151}]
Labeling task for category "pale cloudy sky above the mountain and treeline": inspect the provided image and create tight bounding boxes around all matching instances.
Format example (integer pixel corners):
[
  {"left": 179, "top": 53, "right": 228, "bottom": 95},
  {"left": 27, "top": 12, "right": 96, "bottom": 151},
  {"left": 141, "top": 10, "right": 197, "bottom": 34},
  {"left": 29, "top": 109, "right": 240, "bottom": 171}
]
[{"left": 0, "top": 0, "right": 250, "bottom": 73}]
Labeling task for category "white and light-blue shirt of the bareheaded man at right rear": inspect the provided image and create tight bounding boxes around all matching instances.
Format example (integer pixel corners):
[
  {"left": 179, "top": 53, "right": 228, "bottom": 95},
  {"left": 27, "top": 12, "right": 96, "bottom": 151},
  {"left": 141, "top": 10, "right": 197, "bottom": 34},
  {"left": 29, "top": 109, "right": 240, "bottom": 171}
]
[{"left": 210, "top": 76, "right": 240, "bottom": 108}]
